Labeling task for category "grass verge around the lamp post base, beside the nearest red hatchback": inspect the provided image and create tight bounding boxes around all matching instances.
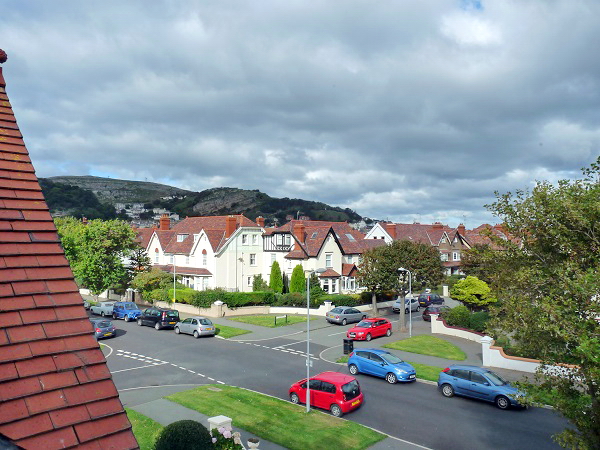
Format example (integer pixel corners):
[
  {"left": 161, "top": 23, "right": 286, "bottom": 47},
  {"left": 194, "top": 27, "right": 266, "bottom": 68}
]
[{"left": 167, "top": 385, "right": 385, "bottom": 450}]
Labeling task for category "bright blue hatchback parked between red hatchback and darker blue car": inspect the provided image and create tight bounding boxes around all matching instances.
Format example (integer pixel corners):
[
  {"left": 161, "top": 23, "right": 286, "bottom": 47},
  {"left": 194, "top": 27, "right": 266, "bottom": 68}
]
[{"left": 348, "top": 348, "right": 417, "bottom": 384}]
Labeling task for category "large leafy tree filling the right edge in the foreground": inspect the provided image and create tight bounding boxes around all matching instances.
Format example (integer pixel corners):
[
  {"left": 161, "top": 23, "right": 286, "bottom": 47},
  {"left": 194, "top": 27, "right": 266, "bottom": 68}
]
[{"left": 488, "top": 158, "right": 600, "bottom": 449}]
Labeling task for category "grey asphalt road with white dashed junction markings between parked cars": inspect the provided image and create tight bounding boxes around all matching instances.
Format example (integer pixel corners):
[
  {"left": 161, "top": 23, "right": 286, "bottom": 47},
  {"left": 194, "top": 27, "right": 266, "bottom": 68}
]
[{"left": 103, "top": 310, "right": 566, "bottom": 449}]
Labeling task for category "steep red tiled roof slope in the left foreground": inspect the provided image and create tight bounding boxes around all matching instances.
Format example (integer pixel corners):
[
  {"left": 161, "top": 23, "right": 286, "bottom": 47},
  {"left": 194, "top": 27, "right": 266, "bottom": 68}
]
[{"left": 0, "top": 61, "right": 138, "bottom": 449}]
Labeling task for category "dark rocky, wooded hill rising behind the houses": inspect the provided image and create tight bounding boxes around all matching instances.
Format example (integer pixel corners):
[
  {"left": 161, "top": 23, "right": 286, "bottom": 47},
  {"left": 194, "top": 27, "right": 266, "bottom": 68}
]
[{"left": 40, "top": 176, "right": 362, "bottom": 225}]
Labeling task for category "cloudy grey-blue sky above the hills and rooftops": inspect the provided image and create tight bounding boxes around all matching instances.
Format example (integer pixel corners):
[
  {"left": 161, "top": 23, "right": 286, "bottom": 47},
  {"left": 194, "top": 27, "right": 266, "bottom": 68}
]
[{"left": 0, "top": 0, "right": 600, "bottom": 228}]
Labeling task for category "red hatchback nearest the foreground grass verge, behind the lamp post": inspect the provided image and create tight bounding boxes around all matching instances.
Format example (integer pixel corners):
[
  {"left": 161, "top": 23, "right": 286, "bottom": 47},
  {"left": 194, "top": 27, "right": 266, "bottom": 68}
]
[{"left": 288, "top": 372, "right": 364, "bottom": 417}]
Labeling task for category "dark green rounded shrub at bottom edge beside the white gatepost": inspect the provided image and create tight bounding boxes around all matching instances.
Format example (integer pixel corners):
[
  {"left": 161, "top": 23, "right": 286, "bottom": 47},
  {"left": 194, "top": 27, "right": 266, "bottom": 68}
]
[{"left": 154, "top": 420, "right": 214, "bottom": 450}]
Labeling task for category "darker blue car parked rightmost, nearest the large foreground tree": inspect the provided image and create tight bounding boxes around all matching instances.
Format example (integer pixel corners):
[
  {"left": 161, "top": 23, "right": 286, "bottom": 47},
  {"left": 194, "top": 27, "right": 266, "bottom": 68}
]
[{"left": 438, "top": 365, "right": 523, "bottom": 409}]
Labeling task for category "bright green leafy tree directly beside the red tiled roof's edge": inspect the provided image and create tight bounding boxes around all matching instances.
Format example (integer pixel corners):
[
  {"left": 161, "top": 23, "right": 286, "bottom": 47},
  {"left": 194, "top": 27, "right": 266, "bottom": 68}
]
[{"left": 55, "top": 219, "right": 138, "bottom": 296}]
